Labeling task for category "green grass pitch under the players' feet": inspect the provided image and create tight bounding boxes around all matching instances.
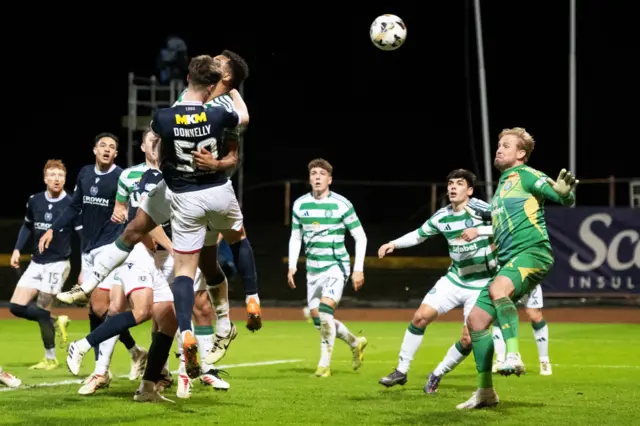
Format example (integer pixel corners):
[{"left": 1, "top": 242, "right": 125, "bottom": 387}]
[{"left": 0, "top": 320, "right": 640, "bottom": 425}]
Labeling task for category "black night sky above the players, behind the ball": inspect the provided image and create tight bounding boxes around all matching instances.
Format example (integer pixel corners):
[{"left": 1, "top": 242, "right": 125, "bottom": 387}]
[{"left": 3, "top": 0, "right": 640, "bottom": 217}]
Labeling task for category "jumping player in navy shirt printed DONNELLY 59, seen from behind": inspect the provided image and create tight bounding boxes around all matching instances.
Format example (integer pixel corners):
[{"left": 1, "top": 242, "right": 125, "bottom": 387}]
[{"left": 143, "top": 56, "right": 249, "bottom": 377}]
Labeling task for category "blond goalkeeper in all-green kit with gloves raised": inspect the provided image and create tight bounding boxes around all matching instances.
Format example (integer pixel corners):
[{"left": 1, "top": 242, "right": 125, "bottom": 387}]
[{"left": 458, "top": 127, "right": 578, "bottom": 409}]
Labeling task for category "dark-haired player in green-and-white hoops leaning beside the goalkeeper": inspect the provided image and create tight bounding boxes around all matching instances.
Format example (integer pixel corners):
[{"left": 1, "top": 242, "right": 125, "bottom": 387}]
[{"left": 378, "top": 169, "right": 498, "bottom": 393}]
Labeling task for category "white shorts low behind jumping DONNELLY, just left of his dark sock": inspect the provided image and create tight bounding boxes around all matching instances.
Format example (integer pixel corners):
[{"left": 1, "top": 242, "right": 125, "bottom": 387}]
[{"left": 117, "top": 243, "right": 173, "bottom": 303}]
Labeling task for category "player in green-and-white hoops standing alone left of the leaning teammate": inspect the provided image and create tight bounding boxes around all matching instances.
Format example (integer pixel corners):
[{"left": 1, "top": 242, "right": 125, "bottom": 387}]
[{"left": 287, "top": 158, "right": 368, "bottom": 377}]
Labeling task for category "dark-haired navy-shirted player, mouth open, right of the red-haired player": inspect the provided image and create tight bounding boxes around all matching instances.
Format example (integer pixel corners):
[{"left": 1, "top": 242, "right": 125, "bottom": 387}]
[{"left": 39, "top": 133, "right": 144, "bottom": 395}]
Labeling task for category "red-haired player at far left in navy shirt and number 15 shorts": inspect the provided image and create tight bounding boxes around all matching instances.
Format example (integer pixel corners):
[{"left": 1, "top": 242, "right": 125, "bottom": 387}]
[{"left": 9, "top": 160, "right": 82, "bottom": 370}]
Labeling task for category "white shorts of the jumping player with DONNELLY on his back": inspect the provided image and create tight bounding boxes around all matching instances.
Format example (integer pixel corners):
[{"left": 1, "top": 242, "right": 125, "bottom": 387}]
[{"left": 140, "top": 181, "right": 243, "bottom": 253}]
